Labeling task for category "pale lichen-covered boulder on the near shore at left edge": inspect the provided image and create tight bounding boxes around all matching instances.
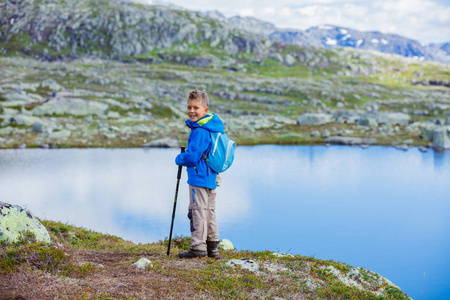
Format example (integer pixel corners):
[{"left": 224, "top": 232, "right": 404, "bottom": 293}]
[{"left": 0, "top": 202, "right": 50, "bottom": 243}]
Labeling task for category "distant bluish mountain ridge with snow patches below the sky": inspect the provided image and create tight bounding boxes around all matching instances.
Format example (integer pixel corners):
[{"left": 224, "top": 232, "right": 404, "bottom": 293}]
[{"left": 206, "top": 11, "right": 450, "bottom": 63}]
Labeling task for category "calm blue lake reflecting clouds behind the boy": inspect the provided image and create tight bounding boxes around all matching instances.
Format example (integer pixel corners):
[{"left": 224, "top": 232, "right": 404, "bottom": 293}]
[{"left": 0, "top": 146, "right": 450, "bottom": 299}]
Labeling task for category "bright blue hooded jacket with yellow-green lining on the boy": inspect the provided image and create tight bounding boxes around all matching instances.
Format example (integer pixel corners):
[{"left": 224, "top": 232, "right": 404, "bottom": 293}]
[{"left": 175, "top": 114, "right": 224, "bottom": 189}]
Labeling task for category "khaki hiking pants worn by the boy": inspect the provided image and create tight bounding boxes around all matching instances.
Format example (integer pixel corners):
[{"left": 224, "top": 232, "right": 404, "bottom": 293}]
[{"left": 188, "top": 185, "right": 219, "bottom": 251}]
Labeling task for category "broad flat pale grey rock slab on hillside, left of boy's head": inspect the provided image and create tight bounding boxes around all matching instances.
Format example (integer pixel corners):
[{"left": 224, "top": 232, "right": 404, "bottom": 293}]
[{"left": 32, "top": 98, "right": 109, "bottom": 116}]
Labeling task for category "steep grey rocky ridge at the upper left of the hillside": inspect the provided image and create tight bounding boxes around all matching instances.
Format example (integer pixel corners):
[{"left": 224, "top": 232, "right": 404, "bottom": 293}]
[{"left": 0, "top": 0, "right": 271, "bottom": 61}]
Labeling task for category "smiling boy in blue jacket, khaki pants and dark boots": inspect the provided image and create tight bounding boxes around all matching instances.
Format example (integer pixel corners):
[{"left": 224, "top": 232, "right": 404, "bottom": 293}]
[{"left": 175, "top": 90, "right": 224, "bottom": 259}]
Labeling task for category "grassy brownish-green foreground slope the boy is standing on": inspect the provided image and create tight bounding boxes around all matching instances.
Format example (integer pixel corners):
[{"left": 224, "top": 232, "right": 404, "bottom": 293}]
[{"left": 0, "top": 221, "right": 409, "bottom": 300}]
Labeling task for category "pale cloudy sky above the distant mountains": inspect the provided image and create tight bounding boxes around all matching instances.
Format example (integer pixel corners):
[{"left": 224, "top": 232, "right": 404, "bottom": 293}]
[{"left": 140, "top": 0, "right": 450, "bottom": 44}]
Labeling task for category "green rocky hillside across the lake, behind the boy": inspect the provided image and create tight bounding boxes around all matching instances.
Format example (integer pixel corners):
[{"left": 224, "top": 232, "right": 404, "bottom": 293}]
[{"left": 0, "top": 0, "right": 450, "bottom": 151}]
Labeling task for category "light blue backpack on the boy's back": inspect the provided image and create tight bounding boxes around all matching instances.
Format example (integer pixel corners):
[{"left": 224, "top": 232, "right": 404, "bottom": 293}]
[{"left": 202, "top": 131, "right": 236, "bottom": 173}]
